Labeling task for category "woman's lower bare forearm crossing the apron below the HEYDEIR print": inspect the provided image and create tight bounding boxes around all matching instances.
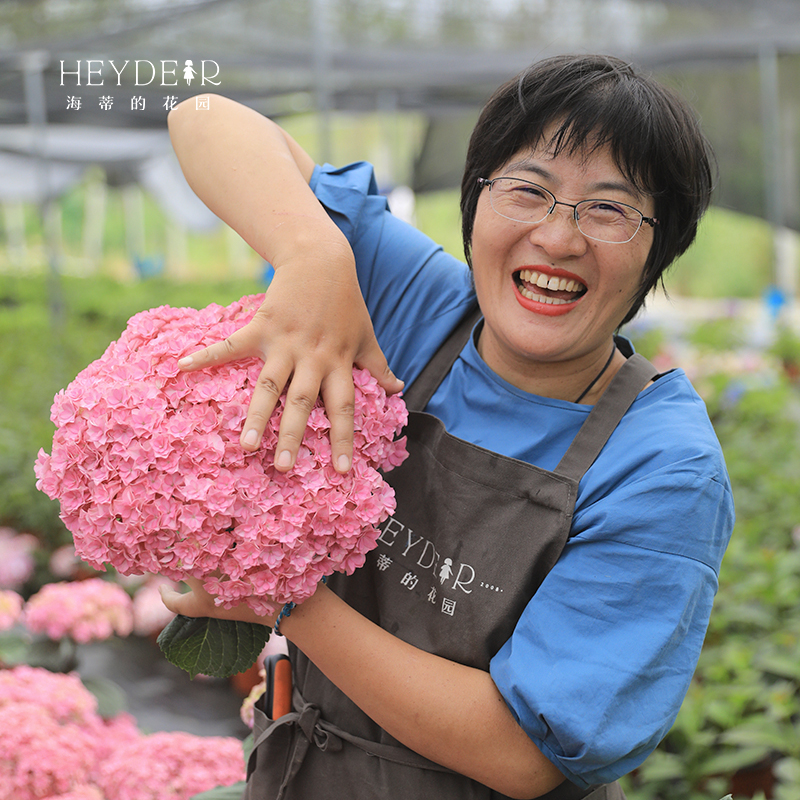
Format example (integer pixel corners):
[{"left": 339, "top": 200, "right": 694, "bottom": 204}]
[{"left": 281, "top": 587, "right": 563, "bottom": 798}]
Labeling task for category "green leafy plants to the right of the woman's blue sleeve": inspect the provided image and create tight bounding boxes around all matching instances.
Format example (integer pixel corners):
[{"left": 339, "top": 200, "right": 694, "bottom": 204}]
[{"left": 625, "top": 378, "right": 800, "bottom": 800}]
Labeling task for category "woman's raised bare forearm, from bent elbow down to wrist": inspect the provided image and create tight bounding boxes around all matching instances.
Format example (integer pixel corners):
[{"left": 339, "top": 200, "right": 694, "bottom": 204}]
[{"left": 168, "top": 95, "right": 349, "bottom": 268}]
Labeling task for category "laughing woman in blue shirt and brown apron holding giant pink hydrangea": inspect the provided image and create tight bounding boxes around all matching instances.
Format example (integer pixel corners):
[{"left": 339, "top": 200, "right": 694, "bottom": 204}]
[{"left": 162, "top": 56, "right": 733, "bottom": 800}]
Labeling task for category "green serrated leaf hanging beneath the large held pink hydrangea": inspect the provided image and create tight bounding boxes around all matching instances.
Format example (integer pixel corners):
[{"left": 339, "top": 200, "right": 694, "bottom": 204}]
[{"left": 158, "top": 614, "right": 272, "bottom": 678}]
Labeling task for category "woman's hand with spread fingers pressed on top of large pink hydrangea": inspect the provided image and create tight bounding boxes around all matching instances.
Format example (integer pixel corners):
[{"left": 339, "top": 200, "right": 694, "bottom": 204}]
[{"left": 179, "top": 238, "right": 403, "bottom": 473}]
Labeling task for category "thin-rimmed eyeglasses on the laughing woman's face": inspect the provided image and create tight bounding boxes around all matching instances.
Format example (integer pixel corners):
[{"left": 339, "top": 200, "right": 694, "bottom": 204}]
[{"left": 478, "top": 178, "right": 658, "bottom": 244}]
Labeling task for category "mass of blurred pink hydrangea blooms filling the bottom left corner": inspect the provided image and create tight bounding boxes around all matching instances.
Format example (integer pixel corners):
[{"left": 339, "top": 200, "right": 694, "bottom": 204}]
[{"left": 0, "top": 666, "right": 244, "bottom": 800}]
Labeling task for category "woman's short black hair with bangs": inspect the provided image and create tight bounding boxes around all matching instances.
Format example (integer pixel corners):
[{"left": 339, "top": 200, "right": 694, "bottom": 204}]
[{"left": 461, "top": 55, "right": 716, "bottom": 325}]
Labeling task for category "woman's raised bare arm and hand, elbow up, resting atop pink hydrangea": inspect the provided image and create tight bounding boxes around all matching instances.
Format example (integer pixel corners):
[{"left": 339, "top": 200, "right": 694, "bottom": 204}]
[{"left": 169, "top": 95, "right": 402, "bottom": 472}]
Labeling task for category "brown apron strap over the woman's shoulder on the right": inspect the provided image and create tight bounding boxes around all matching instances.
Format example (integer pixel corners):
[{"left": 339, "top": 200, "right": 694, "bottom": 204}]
[{"left": 555, "top": 353, "right": 659, "bottom": 481}]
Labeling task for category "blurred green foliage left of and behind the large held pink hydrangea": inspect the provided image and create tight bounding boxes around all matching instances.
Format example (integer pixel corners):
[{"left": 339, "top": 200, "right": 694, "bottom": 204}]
[{"left": 0, "top": 276, "right": 263, "bottom": 560}]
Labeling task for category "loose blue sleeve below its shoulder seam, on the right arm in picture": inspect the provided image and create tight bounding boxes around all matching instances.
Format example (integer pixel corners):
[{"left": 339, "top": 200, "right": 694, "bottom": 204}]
[{"left": 491, "top": 449, "right": 733, "bottom": 787}]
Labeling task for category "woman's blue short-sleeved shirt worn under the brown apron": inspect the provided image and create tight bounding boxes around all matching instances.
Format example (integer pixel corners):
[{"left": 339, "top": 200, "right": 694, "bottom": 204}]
[{"left": 311, "top": 163, "right": 733, "bottom": 787}]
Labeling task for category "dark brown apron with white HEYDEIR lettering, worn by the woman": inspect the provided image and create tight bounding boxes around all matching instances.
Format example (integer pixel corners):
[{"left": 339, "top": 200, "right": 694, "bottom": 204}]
[{"left": 244, "top": 311, "right": 657, "bottom": 800}]
